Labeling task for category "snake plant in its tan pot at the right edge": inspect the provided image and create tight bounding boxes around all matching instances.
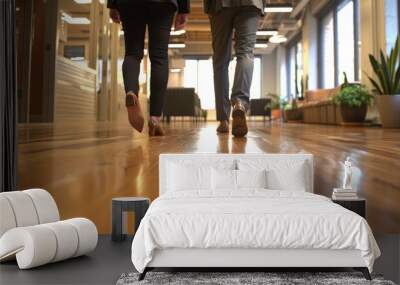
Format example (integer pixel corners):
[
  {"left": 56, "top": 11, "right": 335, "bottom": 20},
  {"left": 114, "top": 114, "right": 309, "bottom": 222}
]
[{"left": 368, "top": 37, "right": 400, "bottom": 128}]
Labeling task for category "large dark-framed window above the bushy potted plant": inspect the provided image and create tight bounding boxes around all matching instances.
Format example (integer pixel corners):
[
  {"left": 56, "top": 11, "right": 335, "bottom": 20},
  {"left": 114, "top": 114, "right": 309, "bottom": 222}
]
[{"left": 319, "top": 0, "right": 361, "bottom": 88}]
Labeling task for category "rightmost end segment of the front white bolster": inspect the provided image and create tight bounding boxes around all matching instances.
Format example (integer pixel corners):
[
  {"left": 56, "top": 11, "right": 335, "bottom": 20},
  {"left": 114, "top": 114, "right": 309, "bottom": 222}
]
[{"left": 64, "top": 218, "right": 98, "bottom": 257}]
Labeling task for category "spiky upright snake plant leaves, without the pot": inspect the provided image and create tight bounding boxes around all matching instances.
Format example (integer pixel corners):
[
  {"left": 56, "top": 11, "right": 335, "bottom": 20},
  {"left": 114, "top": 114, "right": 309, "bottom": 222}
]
[{"left": 368, "top": 37, "right": 400, "bottom": 95}]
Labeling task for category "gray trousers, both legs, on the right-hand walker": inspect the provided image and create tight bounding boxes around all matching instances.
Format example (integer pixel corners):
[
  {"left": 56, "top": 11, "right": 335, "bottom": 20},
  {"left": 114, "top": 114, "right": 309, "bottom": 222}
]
[{"left": 210, "top": 6, "right": 260, "bottom": 121}]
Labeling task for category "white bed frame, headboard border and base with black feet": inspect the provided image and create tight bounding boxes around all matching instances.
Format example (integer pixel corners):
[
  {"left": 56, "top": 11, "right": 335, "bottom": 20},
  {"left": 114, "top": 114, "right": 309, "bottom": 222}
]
[{"left": 139, "top": 154, "right": 371, "bottom": 280}]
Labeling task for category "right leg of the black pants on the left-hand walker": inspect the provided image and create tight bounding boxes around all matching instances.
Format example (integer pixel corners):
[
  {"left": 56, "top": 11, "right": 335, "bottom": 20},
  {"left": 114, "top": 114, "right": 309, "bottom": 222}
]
[{"left": 147, "top": 3, "right": 176, "bottom": 117}]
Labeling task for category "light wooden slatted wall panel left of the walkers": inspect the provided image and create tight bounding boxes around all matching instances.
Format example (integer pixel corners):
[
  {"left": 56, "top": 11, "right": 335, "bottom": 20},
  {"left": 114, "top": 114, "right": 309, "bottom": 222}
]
[{"left": 54, "top": 57, "right": 97, "bottom": 123}]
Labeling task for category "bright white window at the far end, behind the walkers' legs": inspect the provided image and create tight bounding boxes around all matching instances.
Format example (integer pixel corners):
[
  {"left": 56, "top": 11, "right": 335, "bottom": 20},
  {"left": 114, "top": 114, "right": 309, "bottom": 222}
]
[{"left": 183, "top": 57, "right": 261, "bottom": 110}]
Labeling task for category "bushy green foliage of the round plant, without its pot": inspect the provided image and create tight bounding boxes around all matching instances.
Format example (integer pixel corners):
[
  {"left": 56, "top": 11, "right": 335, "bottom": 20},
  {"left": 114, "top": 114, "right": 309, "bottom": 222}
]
[{"left": 333, "top": 84, "right": 372, "bottom": 108}]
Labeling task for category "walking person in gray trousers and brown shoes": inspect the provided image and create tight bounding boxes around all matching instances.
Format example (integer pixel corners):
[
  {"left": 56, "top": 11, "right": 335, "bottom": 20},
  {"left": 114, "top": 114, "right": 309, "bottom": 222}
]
[{"left": 204, "top": 0, "right": 265, "bottom": 137}]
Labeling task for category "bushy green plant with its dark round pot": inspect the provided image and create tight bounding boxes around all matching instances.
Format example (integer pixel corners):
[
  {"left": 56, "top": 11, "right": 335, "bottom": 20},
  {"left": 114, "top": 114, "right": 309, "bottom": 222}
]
[{"left": 333, "top": 73, "right": 372, "bottom": 123}]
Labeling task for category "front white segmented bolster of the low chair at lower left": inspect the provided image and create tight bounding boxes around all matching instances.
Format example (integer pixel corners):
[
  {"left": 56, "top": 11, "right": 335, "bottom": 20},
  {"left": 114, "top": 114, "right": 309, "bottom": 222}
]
[{"left": 0, "top": 218, "right": 98, "bottom": 269}]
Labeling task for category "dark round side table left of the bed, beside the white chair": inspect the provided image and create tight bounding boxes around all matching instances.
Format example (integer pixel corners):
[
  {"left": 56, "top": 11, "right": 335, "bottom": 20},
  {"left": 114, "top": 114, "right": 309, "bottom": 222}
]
[{"left": 111, "top": 197, "right": 150, "bottom": 241}]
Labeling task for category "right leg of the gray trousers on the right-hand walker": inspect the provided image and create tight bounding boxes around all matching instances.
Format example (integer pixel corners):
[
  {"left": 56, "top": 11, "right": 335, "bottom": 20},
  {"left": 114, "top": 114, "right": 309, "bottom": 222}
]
[{"left": 231, "top": 7, "right": 260, "bottom": 105}]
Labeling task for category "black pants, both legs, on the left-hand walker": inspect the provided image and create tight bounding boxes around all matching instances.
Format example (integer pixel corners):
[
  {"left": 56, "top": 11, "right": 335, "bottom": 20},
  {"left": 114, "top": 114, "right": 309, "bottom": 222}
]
[{"left": 118, "top": 1, "right": 176, "bottom": 116}]
